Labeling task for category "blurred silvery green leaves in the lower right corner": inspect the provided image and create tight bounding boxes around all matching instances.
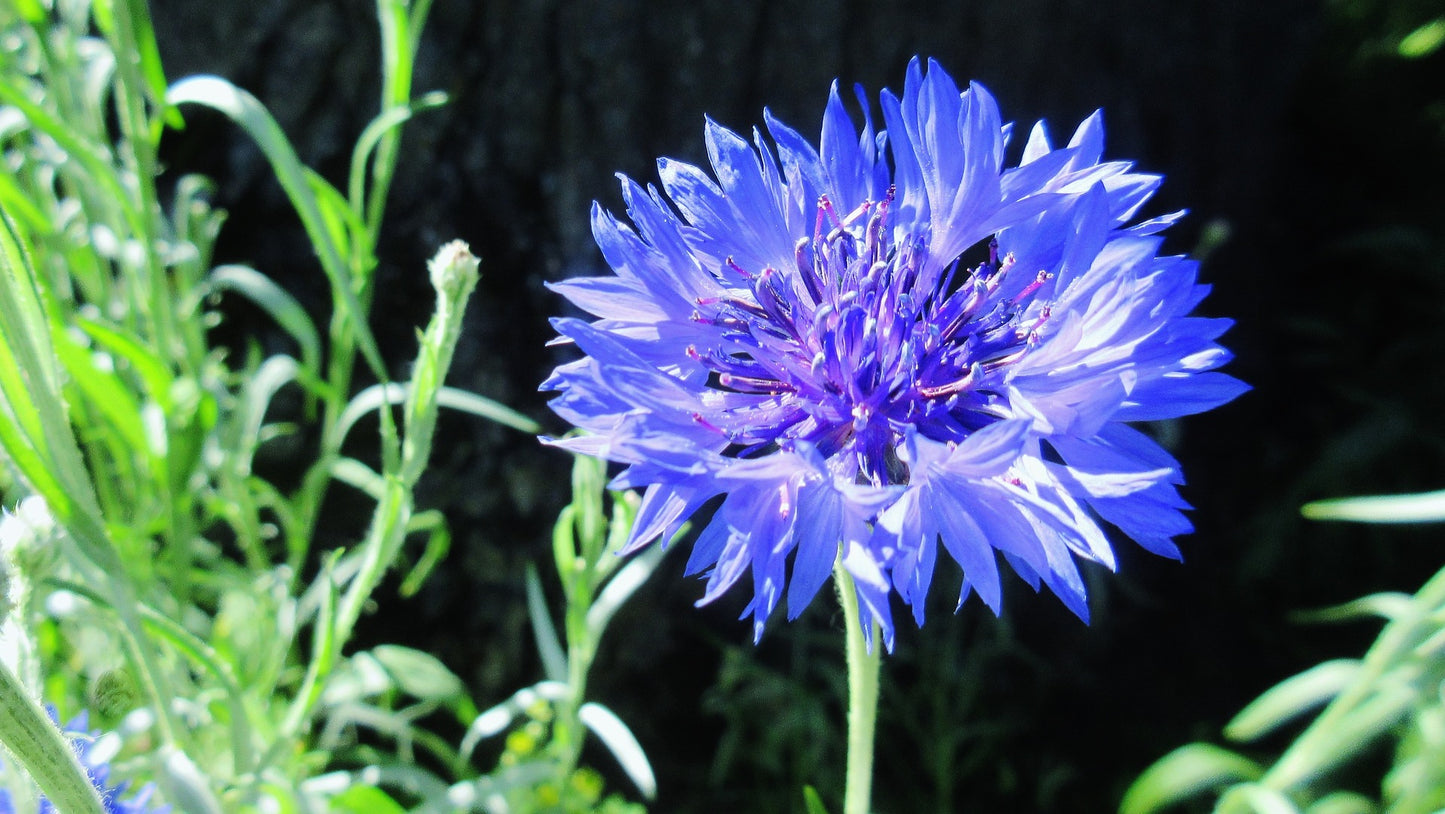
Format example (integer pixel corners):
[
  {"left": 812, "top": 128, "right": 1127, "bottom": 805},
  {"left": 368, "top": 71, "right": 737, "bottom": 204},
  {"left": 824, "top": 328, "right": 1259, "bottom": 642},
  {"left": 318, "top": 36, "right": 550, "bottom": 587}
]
[{"left": 1120, "top": 503, "right": 1445, "bottom": 814}]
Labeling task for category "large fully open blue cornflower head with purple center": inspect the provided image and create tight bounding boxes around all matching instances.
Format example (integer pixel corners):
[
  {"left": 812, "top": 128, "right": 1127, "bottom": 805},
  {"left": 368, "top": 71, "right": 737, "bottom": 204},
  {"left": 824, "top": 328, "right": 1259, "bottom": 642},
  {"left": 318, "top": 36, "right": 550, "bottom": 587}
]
[{"left": 542, "top": 59, "right": 1247, "bottom": 648}]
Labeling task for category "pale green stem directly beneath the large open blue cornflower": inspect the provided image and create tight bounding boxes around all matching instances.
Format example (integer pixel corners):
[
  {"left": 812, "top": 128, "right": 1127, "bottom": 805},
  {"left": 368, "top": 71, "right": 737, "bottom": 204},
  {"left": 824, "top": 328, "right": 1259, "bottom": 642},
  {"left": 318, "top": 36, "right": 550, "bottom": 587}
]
[{"left": 832, "top": 560, "right": 883, "bottom": 814}]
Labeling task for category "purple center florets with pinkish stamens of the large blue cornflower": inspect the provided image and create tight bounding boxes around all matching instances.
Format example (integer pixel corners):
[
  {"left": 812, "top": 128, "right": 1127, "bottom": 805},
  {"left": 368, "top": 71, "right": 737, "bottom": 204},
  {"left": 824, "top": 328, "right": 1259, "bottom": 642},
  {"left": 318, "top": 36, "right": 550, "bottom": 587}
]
[{"left": 688, "top": 189, "right": 1051, "bottom": 484}]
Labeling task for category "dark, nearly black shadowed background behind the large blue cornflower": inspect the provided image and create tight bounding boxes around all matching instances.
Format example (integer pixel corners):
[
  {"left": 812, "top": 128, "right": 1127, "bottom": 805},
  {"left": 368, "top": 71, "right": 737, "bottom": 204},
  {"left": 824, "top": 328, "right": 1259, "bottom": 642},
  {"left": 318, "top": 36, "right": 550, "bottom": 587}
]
[{"left": 152, "top": 0, "right": 1445, "bottom": 813}]
